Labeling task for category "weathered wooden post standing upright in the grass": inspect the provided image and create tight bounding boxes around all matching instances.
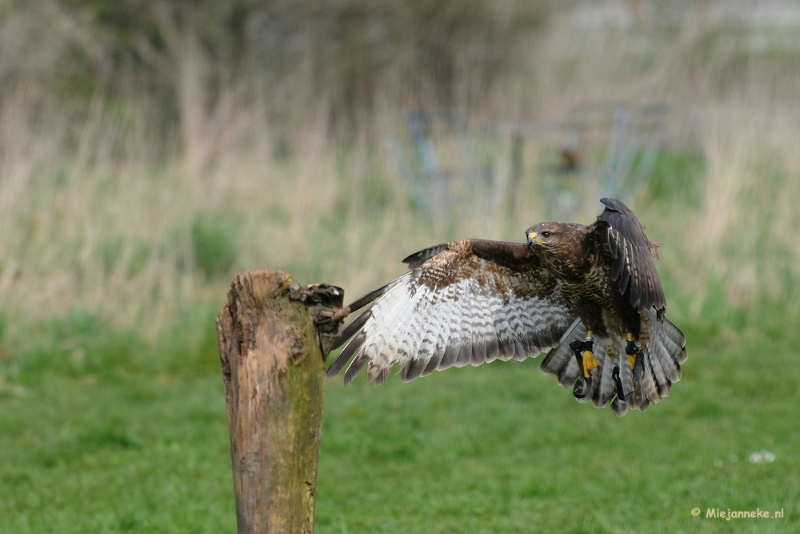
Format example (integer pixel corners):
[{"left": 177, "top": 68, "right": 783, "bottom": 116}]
[{"left": 217, "top": 270, "right": 343, "bottom": 534}]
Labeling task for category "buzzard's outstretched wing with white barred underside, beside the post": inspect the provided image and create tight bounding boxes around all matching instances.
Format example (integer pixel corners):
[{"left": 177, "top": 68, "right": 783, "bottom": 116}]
[{"left": 328, "top": 240, "right": 575, "bottom": 385}]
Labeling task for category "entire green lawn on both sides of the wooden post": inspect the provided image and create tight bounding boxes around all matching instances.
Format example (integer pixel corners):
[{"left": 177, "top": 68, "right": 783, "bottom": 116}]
[{"left": 0, "top": 304, "right": 800, "bottom": 533}]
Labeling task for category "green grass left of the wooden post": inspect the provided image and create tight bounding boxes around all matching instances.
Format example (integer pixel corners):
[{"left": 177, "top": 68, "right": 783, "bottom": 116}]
[{"left": 0, "top": 314, "right": 235, "bottom": 533}]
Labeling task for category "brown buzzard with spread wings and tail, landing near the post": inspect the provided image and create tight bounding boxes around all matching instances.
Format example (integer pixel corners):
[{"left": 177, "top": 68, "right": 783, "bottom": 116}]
[{"left": 328, "top": 198, "right": 687, "bottom": 416}]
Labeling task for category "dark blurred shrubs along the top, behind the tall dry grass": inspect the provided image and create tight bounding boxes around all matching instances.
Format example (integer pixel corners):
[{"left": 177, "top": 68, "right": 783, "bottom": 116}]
[{"left": 0, "top": 0, "right": 548, "bottom": 160}]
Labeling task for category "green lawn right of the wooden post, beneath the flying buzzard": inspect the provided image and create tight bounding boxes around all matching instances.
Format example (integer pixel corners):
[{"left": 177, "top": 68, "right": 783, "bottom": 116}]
[{"left": 318, "top": 328, "right": 800, "bottom": 532}]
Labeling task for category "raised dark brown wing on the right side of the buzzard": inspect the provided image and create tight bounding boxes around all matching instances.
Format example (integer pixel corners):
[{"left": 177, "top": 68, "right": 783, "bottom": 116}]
[{"left": 594, "top": 198, "right": 667, "bottom": 312}]
